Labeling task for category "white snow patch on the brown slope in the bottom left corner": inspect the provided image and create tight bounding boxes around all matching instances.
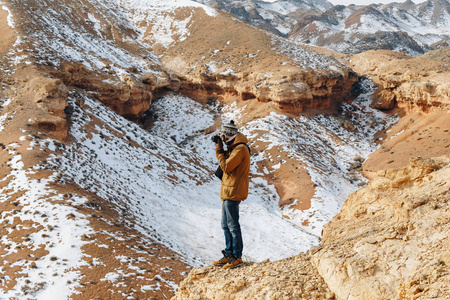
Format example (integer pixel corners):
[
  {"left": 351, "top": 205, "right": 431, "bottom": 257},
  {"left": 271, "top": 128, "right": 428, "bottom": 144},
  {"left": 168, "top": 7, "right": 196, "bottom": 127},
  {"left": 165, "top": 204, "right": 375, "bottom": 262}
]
[{"left": 0, "top": 143, "right": 92, "bottom": 299}]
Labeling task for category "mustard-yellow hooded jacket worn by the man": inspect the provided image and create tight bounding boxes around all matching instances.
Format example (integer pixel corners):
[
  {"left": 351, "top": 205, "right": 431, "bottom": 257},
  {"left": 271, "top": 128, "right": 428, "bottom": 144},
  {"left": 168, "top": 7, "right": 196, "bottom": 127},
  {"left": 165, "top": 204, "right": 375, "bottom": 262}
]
[{"left": 216, "top": 133, "right": 250, "bottom": 201}]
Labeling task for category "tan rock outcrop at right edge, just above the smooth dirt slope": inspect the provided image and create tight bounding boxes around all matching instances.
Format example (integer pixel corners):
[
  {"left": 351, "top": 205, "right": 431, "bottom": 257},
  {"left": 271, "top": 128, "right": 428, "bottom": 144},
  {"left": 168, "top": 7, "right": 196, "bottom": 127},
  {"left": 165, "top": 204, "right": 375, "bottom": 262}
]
[{"left": 350, "top": 50, "right": 450, "bottom": 113}]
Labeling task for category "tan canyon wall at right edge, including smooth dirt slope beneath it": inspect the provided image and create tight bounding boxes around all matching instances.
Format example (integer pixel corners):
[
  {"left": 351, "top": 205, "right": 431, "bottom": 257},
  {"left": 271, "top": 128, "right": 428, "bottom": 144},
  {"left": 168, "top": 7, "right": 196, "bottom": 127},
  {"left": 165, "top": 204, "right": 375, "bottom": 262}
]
[{"left": 349, "top": 49, "right": 450, "bottom": 178}]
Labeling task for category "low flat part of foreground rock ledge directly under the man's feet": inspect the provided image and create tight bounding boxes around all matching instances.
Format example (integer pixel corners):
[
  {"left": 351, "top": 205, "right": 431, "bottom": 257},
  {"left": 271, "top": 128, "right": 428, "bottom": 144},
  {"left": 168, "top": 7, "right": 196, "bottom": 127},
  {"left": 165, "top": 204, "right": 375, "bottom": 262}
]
[{"left": 172, "top": 253, "right": 334, "bottom": 300}]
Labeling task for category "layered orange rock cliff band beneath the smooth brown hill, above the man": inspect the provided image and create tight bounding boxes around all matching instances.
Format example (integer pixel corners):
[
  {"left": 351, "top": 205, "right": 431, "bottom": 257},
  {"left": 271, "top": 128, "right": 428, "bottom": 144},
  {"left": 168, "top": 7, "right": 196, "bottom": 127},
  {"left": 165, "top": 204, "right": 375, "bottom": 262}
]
[{"left": 177, "top": 66, "right": 357, "bottom": 113}]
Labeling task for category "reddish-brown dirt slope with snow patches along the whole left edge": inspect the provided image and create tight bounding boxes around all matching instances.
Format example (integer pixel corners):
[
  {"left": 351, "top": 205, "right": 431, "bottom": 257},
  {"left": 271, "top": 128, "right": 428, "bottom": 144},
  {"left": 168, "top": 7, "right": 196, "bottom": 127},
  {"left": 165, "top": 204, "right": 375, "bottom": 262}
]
[{"left": 0, "top": 3, "right": 190, "bottom": 299}]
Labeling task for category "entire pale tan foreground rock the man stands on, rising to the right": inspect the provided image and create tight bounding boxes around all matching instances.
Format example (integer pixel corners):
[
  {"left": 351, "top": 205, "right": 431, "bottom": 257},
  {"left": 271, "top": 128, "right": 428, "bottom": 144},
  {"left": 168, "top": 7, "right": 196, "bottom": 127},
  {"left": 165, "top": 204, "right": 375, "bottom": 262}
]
[{"left": 173, "top": 156, "right": 450, "bottom": 299}]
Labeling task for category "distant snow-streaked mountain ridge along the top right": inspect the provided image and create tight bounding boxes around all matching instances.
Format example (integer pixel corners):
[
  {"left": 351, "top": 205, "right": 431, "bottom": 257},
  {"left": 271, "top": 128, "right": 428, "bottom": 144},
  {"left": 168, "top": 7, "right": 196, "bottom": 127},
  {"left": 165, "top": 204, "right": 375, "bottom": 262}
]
[{"left": 199, "top": 0, "right": 450, "bottom": 56}]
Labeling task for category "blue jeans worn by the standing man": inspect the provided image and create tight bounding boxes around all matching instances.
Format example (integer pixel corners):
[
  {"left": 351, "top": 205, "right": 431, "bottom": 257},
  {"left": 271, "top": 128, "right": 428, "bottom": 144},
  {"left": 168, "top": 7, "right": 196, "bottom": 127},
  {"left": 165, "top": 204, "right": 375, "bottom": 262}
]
[{"left": 222, "top": 200, "right": 244, "bottom": 258}]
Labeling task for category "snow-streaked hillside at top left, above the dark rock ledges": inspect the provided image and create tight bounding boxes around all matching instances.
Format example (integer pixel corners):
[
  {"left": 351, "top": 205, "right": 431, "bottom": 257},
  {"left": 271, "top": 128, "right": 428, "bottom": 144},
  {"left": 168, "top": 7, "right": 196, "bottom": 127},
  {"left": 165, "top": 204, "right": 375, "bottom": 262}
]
[{"left": 0, "top": 0, "right": 215, "bottom": 75}]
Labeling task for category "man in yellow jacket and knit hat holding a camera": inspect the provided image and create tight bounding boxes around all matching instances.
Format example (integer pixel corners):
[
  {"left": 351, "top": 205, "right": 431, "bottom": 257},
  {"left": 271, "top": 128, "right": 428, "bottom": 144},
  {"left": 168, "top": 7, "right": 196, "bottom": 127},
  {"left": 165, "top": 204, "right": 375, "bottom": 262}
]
[{"left": 213, "top": 121, "right": 250, "bottom": 268}]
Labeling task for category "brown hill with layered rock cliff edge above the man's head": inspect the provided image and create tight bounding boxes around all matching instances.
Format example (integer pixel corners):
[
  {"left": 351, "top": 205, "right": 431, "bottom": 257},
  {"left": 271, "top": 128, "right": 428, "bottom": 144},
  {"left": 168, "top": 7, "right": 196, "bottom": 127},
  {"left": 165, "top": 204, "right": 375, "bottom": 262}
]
[{"left": 155, "top": 11, "right": 357, "bottom": 112}]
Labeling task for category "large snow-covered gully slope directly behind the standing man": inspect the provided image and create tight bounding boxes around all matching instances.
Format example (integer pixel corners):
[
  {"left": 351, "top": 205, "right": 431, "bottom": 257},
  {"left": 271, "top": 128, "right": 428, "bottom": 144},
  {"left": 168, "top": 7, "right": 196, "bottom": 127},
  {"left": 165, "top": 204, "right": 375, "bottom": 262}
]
[{"left": 49, "top": 96, "right": 318, "bottom": 264}]
